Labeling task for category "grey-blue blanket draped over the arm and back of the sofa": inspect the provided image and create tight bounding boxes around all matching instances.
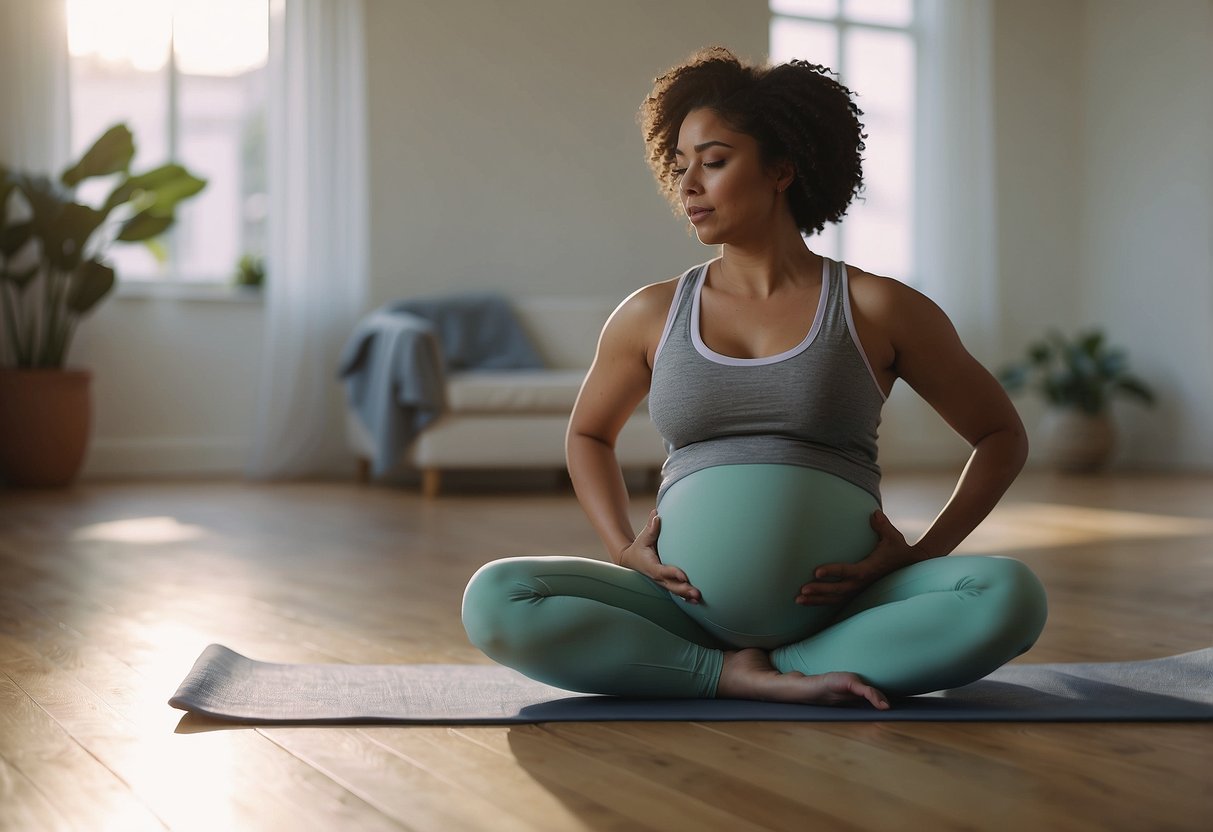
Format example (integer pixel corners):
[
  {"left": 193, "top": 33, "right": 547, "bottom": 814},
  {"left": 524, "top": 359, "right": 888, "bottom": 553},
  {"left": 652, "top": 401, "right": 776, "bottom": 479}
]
[{"left": 337, "top": 292, "right": 543, "bottom": 477}]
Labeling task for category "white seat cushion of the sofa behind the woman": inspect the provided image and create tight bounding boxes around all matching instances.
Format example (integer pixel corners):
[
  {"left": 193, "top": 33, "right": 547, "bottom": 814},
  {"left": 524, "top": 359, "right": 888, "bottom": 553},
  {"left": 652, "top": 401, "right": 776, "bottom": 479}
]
[{"left": 446, "top": 370, "right": 586, "bottom": 416}]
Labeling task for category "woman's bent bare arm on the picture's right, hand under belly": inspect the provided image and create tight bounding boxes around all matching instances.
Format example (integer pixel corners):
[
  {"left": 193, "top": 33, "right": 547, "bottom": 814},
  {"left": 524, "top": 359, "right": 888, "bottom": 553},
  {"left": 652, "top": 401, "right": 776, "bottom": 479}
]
[{"left": 797, "top": 275, "right": 1027, "bottom": 604}]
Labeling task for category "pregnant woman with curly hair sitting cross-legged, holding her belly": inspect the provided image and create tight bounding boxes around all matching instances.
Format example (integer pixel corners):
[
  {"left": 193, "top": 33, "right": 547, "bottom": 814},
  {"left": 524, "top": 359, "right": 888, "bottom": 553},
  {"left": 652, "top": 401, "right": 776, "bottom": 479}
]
[{"left": 463, "top": 47, "right": 1046, "bottom": 710}]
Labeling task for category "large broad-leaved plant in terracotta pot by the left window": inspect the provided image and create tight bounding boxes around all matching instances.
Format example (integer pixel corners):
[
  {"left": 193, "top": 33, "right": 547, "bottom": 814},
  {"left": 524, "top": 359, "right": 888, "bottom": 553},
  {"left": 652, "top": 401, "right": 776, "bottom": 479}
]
[{"left": 0, "top": 124, "right": 206, "bottom": 486}]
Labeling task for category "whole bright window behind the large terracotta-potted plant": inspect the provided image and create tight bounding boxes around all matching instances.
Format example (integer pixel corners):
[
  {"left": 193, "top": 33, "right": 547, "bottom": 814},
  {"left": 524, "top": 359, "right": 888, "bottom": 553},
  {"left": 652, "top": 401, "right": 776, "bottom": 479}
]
[{"left": 67, "top": 0, "right": 269, "bottom": 283}]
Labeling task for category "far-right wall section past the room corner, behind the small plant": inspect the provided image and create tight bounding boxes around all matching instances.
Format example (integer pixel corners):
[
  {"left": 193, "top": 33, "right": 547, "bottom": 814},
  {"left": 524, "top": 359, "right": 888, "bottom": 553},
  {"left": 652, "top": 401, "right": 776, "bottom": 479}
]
[{"left": 1078, "top": 0, "right": 1213, "bottom": 469}]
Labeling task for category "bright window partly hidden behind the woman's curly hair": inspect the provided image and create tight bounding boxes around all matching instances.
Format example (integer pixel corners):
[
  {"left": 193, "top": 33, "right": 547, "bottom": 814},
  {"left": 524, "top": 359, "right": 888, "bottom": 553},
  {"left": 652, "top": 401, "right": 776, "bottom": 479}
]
[{"left": 770, "top": 0, "right": 916, "bottom": 283}]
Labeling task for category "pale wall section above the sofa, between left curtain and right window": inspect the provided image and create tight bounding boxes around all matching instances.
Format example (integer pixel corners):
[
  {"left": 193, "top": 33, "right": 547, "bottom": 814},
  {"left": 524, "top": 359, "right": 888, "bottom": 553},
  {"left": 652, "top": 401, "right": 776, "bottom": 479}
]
[{"left": 368, "top": 0, "right": 768, "bottom": 301}]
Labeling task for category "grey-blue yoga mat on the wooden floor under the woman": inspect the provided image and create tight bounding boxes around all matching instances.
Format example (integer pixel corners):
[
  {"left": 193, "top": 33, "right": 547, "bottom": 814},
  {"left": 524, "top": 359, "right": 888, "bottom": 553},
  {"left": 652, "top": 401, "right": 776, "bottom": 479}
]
[{"left": 169, "top": 644, "right": 1213, "bottom": 725}]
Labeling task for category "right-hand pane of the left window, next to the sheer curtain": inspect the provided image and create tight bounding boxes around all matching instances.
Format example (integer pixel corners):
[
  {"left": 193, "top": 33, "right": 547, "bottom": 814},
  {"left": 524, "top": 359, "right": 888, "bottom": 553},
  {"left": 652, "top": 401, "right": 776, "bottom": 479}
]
[{"left": 173, "top": 0, "right": 269, "bottom": 281}]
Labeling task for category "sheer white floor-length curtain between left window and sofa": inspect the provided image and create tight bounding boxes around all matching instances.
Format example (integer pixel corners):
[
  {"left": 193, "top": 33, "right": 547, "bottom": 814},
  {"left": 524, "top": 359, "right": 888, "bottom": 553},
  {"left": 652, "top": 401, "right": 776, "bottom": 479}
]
[{"left": 247, "top": 0, "right": 369, "bottom": 479}]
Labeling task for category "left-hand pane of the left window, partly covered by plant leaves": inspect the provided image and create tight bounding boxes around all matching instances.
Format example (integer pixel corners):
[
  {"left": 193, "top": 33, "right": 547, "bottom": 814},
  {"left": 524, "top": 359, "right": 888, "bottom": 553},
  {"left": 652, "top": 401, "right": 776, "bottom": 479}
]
[{"left": 67, "top": 0, "right": 172, "bottom": 279}]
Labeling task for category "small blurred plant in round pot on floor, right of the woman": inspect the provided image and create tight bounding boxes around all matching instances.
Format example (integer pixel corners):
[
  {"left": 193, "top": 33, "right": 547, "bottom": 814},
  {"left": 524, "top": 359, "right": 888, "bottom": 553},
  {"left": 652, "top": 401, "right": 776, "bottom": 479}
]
[{"left": 998, "top": 330, "right": 1155, "bottom": 473}]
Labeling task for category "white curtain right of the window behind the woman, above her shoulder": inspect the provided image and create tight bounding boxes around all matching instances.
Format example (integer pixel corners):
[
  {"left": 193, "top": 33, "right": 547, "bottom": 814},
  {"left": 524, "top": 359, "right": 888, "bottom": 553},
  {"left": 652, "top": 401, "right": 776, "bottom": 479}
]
[{"left": 915, "top": 0, "right": 1001, "bottom": 360}]
